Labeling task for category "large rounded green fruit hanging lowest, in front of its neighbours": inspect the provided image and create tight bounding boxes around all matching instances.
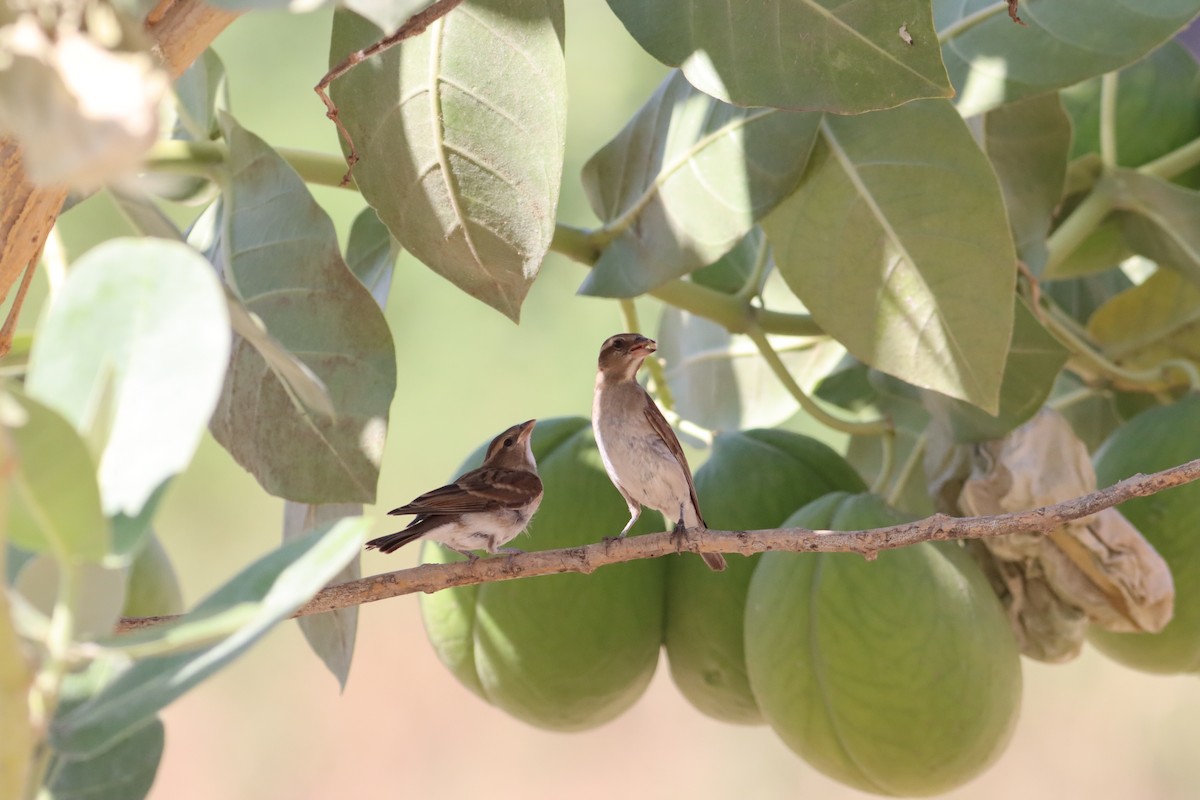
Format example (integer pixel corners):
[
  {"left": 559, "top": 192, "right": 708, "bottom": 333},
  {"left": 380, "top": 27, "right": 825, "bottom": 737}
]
[{"left": 745, "top": 493, "right": 1021, "bottom": 795}]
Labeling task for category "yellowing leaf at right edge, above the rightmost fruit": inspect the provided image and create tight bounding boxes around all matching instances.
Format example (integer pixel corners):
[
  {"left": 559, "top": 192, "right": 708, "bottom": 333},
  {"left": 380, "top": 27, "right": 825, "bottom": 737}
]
[{"left": 1087, "top": 270, "right": 1200, "bottom": 386}]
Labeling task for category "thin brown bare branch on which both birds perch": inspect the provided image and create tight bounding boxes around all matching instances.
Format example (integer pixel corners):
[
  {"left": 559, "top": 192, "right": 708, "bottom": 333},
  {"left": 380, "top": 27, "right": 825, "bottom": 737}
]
[{"left": 116, "top": 459, "right": 1200, "bottom": 633}]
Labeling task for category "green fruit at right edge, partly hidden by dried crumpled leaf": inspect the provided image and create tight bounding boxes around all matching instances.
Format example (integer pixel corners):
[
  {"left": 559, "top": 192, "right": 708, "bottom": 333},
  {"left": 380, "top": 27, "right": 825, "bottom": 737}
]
[{"left": 1088, "top": 393, "right": 1200, "bottom": 673}]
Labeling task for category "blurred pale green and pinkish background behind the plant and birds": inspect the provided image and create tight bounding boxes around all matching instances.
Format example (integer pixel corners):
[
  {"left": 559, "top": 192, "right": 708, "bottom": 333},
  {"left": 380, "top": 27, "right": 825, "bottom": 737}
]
[{"left": 42, "top": 1, "right": 1200, "bottom": 800}]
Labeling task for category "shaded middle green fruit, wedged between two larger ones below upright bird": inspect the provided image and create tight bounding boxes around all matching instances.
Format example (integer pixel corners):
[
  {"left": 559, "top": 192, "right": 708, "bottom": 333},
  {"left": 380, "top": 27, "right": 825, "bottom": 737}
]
[{"left": 665, "top": 431, "right": 866, "bottom": 724}]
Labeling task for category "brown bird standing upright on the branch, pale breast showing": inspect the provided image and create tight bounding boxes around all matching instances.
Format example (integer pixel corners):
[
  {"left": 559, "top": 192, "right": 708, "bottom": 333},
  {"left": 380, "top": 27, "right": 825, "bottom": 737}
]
[{"left": 592, "top": 333, "right": 726, "bottom": 572}]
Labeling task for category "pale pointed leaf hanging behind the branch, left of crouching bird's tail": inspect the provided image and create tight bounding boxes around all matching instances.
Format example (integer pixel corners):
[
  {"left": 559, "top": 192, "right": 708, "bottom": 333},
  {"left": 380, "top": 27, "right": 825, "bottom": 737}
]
[{"left": 283, "top": 503, "right": 360, "bottom": 691}]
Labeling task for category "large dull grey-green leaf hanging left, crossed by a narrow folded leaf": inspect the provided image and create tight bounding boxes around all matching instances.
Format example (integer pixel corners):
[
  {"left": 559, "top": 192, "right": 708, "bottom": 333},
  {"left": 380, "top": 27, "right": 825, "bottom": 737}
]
[{"left": 212, "top": 116, "right": 396, "bottom": 503}]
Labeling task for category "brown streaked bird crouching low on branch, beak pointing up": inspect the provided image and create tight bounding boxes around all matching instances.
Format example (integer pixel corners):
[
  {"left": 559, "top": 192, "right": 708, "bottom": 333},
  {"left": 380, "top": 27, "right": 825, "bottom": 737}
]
[{"left": 366, "top": 420, "right": 542, "bottom": 563}]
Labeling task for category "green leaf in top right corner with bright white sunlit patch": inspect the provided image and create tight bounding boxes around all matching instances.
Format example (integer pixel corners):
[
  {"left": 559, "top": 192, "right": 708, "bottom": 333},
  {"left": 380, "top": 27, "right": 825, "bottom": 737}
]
[{"left": 934, "top": 0, "right": 1200, "bottom": 116}]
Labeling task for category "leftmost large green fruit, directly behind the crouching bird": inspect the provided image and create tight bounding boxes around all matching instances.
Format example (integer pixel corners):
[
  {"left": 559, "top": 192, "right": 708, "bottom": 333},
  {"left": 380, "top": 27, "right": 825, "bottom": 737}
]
[{"left": 421, "top": 417, "right": 664, "bottom": 730}]
